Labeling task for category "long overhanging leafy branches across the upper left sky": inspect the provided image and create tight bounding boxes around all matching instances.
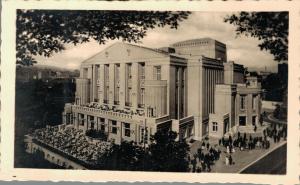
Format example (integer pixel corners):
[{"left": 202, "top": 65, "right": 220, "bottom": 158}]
[{"left": 16, "top": 10, "right": 190, "bottom": 65}]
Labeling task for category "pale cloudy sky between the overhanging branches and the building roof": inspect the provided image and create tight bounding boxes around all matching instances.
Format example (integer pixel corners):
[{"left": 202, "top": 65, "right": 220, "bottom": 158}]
[{"left": 36, "top": 12, "right": 278, "bottom": 72}]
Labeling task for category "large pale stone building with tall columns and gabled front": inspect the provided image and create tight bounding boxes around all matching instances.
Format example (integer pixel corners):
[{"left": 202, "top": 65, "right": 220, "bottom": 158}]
[{"left": 63, "top": 38, "right": 261, "bottom": 143}]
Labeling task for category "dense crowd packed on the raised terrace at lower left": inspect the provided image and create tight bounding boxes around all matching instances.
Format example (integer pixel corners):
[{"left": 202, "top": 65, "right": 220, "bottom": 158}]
[{"left": 32, "top": 127, "right": 111, "bottom": 164}]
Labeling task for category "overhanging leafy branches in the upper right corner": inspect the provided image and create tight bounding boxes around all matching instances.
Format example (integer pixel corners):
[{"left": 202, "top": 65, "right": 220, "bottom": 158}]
[{"left": 224, "top": 12, "right": 289, "bottom": 62}]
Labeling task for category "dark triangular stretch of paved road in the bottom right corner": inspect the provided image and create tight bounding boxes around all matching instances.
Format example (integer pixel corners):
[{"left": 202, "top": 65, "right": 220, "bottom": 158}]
[{"left": 241, "top": 144, "right": 287, "bottom": 174}]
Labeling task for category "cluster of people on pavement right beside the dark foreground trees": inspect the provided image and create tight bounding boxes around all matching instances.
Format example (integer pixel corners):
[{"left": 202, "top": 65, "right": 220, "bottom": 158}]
[{"left": 189, "top": 142, "right": 221, "bottom": 173}]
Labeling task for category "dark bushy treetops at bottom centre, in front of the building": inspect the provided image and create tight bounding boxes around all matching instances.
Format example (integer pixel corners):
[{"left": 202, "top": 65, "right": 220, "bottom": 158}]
[{"left": 98, "top": 131, "right": 189, "bottom": 172}]
